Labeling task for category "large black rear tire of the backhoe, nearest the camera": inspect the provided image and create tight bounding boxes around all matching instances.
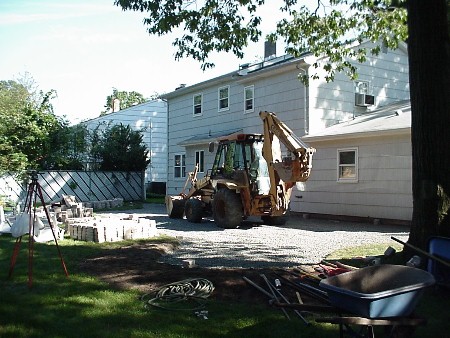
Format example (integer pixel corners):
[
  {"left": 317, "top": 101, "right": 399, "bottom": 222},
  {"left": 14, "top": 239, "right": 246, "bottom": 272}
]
[{"left": 213, "top": 189, "right": 244, "bottom": 229}]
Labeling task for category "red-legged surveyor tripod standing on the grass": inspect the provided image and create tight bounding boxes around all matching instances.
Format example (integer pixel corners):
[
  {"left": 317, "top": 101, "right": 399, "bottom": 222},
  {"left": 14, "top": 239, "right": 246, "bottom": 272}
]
[{"left": 9, "top": 171, "right": 69, "bottom": 288}]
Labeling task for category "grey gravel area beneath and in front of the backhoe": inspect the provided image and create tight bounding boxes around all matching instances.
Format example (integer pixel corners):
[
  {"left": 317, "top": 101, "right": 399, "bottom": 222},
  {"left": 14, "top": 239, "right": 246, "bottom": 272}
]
[{"left": 108, "top": 204, "right": 409, "bottom": 268}]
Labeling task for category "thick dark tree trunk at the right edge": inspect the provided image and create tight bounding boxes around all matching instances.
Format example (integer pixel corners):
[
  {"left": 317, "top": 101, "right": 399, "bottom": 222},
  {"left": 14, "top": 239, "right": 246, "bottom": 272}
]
[{"left": 408, "top": 0, "right": 450, "bottom": 249}]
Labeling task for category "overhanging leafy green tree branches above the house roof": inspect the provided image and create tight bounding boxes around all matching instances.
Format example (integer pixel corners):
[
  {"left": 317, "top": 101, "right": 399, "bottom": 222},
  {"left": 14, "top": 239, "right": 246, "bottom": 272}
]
[{"left": 115, "top": 0, "right": 407, "bottom": 82}]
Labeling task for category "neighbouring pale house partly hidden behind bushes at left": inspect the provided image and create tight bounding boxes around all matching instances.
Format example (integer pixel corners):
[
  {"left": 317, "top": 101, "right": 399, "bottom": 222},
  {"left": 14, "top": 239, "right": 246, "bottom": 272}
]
[{"left": 83, "top": 99, "right": 168, "bottom": 193}]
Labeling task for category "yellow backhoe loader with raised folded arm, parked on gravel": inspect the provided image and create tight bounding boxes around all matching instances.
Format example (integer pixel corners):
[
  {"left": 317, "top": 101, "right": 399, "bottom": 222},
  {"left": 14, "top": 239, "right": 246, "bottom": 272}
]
[{"left": 165, "top": 111, "right": 316, "bottom": 228}]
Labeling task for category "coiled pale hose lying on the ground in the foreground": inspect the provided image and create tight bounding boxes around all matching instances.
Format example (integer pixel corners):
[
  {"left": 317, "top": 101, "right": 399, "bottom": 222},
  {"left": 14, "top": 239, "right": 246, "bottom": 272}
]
[{"left": 141, "top": 278, "right": 214, "bottom": 311}]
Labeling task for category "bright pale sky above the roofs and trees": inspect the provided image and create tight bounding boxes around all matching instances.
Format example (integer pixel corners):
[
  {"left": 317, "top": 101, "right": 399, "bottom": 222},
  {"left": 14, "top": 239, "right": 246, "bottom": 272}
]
[{"left": 0, "top": 0, "right": 282, "bottom": 124}]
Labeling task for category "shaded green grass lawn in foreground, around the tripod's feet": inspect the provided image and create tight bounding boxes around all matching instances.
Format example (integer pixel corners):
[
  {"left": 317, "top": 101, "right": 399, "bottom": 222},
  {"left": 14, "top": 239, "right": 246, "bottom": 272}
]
[{"left": 0, "top": 235, "right": 450, "bottom": 338}]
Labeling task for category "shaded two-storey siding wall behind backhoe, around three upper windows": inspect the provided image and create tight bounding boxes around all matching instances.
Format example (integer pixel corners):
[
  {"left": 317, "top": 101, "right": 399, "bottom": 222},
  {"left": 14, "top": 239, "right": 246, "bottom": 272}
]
[{"left": 167, "top": 70, "right": 305, "bottom": 195}]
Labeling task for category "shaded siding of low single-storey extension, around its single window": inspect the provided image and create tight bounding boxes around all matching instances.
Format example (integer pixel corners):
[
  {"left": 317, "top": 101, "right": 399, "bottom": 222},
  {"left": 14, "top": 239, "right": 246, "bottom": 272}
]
[{"left": 291, "top": 135, "right": 412, "bottom": 221}]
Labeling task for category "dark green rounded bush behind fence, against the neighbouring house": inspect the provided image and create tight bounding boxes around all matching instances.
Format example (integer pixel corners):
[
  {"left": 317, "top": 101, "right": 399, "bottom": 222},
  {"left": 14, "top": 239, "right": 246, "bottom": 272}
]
[{"left": 91, "top": 123, "right": 150, "bottom": 171}]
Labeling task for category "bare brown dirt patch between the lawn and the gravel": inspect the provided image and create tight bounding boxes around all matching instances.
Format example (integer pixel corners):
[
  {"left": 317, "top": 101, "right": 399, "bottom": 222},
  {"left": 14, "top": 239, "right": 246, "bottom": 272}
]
[{"left": 77, "top": 243, "right": 310, "bottom": 303}]
